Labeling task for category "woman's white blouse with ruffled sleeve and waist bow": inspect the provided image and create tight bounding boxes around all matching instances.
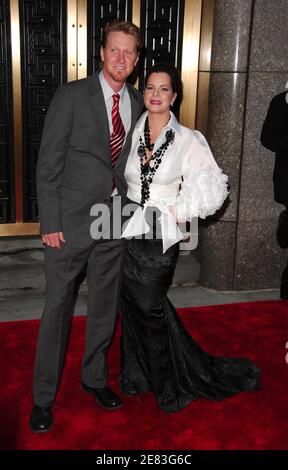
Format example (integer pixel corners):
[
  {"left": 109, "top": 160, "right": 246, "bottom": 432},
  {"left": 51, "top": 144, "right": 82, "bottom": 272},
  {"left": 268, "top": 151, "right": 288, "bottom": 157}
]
[{"left": 122, "top": 111, "right": 228, "bottom": 253}]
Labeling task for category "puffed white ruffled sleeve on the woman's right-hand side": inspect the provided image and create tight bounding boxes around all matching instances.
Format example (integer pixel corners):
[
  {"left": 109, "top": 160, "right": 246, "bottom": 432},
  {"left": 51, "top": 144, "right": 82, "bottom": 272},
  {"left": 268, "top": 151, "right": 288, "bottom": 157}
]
[{"left": 175, "top": 131, "right": 228, "bottom": 220}]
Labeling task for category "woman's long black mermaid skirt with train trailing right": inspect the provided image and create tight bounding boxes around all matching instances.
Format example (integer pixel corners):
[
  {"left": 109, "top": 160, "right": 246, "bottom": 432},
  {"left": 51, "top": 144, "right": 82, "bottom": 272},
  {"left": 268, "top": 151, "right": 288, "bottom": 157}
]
[{"left": 120, "top": 213, "right": 260, "bottom": 412}]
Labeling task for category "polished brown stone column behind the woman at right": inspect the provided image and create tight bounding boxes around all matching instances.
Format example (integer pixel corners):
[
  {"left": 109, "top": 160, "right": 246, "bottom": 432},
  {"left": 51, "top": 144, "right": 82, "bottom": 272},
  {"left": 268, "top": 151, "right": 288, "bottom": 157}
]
[{"left": 200, "top": 0, "right": 288, "bottom": 290}]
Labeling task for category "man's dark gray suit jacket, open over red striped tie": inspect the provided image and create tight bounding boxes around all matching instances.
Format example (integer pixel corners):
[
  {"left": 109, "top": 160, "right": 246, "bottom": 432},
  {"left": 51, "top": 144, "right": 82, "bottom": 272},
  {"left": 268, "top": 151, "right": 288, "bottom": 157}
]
[{"left": 37, "top": 73, "right": 143, "bottom": 247}]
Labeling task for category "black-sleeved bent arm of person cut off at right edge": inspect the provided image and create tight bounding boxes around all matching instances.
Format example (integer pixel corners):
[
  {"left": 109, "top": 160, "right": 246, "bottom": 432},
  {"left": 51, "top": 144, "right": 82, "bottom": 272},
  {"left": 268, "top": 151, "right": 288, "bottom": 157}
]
[{"left": 260, "top": 96, "right": 288, "bottom": 154}]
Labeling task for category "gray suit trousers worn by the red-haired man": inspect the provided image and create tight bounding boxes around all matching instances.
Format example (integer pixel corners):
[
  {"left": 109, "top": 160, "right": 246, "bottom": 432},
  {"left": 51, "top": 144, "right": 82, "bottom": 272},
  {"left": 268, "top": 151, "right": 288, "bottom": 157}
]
[{"left": 34, "top": 240, "right": 123, "bottom": 407}]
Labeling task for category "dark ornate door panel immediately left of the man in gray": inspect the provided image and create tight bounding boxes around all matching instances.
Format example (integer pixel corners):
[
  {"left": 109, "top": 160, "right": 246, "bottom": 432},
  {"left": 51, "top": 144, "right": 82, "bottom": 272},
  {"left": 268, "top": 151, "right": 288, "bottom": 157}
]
[{"left": 20, "top": 0, "right": 67, "bottom": 222}]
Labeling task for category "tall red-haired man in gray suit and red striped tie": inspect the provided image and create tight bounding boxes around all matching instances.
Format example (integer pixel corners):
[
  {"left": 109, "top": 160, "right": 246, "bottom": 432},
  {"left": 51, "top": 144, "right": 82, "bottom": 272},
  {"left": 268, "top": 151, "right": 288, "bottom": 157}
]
[{"left": 30, "top": 20, "right": 143, "bottom": 432}]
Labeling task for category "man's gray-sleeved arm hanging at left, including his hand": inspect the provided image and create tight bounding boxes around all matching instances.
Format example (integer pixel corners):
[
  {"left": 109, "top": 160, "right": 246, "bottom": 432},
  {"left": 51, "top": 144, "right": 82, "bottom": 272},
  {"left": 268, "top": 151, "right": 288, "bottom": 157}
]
[{"left": 36, "top": 82, "right": 73, "bottom": 242}]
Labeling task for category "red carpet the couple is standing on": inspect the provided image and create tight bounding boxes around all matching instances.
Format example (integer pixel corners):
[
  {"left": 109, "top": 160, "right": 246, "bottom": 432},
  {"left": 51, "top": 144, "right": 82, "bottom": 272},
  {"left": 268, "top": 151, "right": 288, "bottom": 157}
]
[{"left": 0, "top": 301, "right": 288, "bottom": 450}]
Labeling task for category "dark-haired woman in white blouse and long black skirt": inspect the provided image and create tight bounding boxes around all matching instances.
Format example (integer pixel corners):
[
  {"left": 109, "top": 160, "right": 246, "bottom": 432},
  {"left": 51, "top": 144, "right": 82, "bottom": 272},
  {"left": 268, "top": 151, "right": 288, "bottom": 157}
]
[{"left": 120, "top": 65, "right": 260, "bottom": 412}]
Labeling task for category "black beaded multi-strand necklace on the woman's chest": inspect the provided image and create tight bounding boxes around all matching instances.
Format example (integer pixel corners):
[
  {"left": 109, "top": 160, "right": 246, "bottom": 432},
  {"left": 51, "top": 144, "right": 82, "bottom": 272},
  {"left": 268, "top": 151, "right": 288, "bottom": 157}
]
[{"left": 138, "top": 116, "right": 175, "bottom": 209}]
